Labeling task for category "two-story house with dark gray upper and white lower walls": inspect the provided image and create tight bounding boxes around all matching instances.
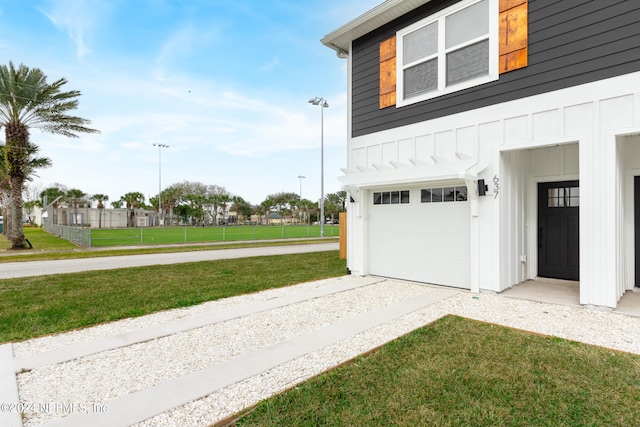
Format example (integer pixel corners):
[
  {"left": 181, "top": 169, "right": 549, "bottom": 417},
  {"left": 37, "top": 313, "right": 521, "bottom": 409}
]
[{"left": 322, "top": 0, "right": 640, "bottom": 307}]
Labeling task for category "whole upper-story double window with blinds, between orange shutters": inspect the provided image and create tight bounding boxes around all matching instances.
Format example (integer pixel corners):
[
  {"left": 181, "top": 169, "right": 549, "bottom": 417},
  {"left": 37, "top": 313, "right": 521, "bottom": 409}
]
[{"left": 396, "top": 0, "right": 498, "bottom": 107}]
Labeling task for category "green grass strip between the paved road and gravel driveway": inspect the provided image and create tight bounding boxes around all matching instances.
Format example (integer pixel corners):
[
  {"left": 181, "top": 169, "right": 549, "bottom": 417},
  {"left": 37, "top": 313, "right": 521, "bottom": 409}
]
[{"left": 0, "top": 251, "right": 346, "bottom": 343}]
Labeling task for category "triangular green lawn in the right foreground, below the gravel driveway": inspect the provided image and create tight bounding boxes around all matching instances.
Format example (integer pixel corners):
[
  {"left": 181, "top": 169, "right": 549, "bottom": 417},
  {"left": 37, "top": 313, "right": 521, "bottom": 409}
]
[{"left": 235, "top": 316, "right": 640, "bottom": 427}]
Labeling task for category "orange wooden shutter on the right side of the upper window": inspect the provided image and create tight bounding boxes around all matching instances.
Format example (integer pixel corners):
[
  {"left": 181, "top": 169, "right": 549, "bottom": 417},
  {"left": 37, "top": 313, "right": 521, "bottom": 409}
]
[{"left": 499, "top": 0, "right": 529, "bottom": 74}]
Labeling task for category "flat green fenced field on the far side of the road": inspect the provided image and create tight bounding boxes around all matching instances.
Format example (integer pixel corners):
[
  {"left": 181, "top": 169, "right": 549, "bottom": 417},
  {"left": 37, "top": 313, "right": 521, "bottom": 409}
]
[{"left": 91, "top": 225, "right": 340, "bottom": 247}]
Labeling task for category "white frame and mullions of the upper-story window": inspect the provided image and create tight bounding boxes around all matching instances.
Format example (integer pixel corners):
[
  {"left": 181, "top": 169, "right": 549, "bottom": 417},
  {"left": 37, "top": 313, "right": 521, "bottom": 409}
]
[{"left": 396, "top": 0, "right": 499, "bottom": 108}]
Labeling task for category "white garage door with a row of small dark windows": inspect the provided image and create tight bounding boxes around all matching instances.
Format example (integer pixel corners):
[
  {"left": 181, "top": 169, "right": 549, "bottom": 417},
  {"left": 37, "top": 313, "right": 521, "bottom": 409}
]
[{"left": 367, "top": 184, "right": 471, "bottom": 289}]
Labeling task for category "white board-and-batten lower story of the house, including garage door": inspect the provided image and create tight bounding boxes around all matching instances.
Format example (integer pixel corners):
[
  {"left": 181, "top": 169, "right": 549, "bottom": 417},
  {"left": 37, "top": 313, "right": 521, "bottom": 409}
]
[{"left": 348, "top": 73, "right": 640, "bottom": 307}]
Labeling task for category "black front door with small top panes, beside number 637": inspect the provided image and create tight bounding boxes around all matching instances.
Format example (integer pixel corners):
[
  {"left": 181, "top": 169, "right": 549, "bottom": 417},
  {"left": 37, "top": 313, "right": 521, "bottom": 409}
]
[{"left": 538, "top": 181, "right": 580, "bottom": 280}]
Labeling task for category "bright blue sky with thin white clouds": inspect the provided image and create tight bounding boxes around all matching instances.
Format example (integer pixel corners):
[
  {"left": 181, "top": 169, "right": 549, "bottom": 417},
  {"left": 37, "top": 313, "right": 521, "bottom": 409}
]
[{"left": 0, "top": 0, "right": 382, "bottom": 204}]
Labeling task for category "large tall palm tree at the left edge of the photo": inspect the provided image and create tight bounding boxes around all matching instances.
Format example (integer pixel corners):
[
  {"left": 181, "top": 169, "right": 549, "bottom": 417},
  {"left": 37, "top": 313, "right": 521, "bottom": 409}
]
[{"left": 0, "top": 62, "right": 98, "bottom": 249}]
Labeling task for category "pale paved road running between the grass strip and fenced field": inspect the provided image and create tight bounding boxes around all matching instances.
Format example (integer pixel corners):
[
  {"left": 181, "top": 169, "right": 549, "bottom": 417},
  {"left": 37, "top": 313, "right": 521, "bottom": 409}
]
[{"left": 0, "top": 242, "right": 339, "bottom": 280}]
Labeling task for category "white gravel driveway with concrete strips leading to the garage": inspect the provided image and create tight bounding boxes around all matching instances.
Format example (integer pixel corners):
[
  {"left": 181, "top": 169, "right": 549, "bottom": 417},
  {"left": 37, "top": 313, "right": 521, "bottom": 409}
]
[{"left": 0, "top": 276, "right": 640, "bottom": 426}]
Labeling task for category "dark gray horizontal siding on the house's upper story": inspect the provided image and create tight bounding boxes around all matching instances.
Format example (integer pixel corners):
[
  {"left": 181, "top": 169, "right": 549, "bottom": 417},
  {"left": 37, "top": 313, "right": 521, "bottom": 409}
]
[{"left": 352, "top": 0, "right": 640, "bottom": 137}]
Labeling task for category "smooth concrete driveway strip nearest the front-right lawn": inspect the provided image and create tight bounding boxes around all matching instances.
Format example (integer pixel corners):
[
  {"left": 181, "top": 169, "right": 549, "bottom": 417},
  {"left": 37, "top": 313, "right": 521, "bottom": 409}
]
[{"left": 46, "top": 289, "right": 458, "bottom": 427}]
